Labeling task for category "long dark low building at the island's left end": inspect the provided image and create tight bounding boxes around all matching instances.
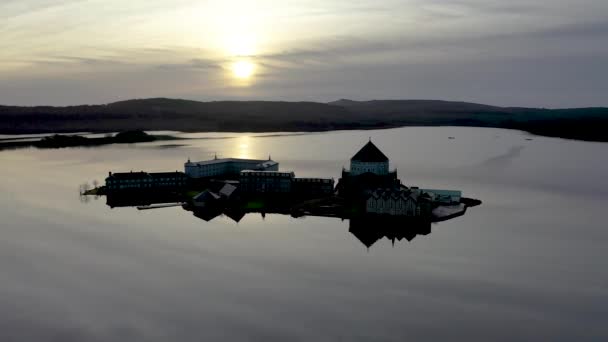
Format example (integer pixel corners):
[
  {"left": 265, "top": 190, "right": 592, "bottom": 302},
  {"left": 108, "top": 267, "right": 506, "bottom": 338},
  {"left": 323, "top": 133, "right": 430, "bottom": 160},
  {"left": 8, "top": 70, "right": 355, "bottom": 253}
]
[{"left": 106, "top": 171, "right": 188, "bottom": 192}]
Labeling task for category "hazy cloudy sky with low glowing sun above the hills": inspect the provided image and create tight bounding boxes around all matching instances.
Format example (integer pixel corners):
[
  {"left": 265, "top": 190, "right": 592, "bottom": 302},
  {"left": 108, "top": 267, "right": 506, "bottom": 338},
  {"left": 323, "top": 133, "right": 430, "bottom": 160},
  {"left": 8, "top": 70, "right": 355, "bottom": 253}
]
[{"left": 0, "top": 0, "right": 608, "bottom": 108}]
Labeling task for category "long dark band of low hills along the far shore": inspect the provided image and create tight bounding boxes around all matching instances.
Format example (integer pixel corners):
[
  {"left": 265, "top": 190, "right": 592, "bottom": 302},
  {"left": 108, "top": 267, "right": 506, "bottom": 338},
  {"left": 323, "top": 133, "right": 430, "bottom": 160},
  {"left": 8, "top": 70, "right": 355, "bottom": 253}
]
[{"left": 0, "top": 98, "right": 608, "bottom": 141}]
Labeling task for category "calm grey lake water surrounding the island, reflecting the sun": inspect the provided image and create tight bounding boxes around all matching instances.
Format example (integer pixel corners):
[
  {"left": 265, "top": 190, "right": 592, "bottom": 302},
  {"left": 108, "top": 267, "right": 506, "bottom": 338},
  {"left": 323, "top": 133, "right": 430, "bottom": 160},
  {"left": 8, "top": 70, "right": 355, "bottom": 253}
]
[{"left": 0, "top": 127, "right": 608, "bottom": 341}]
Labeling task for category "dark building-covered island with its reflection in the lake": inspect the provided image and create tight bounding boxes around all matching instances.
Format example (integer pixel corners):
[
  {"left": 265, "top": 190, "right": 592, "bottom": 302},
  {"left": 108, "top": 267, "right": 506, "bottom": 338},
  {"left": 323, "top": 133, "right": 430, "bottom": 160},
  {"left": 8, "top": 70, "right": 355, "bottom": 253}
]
[{"left": 83, "top": 139, "right": 481, "bottom": 247}]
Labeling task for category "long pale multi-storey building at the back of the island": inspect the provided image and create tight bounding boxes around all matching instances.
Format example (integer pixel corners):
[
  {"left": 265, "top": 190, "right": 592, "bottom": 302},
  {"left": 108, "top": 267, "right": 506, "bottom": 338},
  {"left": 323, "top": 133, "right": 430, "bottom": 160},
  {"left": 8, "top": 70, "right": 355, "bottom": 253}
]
[{"left": 184, "top": 156, "right": 279, "bottom": 178}]
